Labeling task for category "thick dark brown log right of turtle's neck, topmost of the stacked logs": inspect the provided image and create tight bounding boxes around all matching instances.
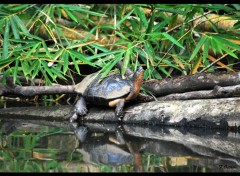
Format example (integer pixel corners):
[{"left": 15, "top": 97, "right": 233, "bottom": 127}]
[{"left": 142, "top": 72, "right": 240, "bottom": 98}]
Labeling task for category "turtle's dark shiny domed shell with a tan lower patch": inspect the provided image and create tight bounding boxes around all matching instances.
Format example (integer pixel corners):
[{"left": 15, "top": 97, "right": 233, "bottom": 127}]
[{"left": 83, "top": 74, "right": 133, "bottom": 105}]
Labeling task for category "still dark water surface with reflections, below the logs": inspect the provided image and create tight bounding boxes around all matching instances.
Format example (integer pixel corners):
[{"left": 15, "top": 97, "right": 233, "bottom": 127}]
[{"left": 0, "top": 118, "right": 240, "bottom": 172}]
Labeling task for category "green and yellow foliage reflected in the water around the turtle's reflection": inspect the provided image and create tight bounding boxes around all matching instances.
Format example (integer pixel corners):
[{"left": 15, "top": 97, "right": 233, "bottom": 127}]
[{"left": 0, "top": 126, "right": 218, "bottom": 172}]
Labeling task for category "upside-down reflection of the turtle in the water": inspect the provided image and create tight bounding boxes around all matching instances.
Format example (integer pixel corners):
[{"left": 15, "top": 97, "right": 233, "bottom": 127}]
[{"left": 72, "top": 126, "right": 144, "bottom": 172}]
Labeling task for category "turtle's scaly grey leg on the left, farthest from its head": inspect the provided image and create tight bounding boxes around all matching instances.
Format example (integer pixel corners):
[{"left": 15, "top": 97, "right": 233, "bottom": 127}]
[{"left": 70, "top": 96, "right": 87, "bottom": 122}]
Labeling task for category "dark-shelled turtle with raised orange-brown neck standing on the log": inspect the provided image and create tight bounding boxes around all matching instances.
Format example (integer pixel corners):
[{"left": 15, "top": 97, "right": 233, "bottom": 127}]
[{"left": 70, "top": 66, "right": 144, "bottom": 122}]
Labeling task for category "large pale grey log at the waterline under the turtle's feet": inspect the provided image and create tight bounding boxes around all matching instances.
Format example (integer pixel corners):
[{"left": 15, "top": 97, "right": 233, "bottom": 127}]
[{"left": 0, "top": 98, "right": 240, "bottom": 128}]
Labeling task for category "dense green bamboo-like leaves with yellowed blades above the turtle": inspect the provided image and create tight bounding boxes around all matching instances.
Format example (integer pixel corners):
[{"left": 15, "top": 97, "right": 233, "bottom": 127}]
[{"left": 0, "top": 4, "right": 240, "bottom": 84}]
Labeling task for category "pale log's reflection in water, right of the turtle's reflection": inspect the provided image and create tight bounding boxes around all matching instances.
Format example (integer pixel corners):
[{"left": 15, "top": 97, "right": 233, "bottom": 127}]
[{"left": 125, "top": 126, "right": 240, "bottom": 164}]
